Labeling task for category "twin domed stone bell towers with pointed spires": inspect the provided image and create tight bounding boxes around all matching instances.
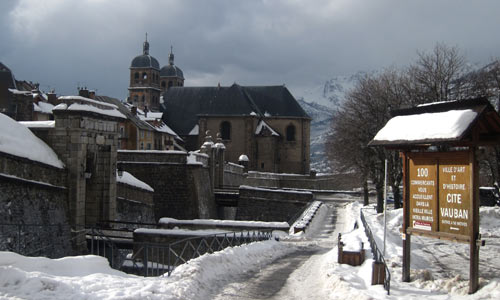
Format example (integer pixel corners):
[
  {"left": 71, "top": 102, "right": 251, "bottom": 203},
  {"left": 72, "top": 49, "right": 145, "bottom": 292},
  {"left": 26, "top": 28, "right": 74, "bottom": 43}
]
[{"left": 127, "top": 35, "right": 184, "bottom": 111}]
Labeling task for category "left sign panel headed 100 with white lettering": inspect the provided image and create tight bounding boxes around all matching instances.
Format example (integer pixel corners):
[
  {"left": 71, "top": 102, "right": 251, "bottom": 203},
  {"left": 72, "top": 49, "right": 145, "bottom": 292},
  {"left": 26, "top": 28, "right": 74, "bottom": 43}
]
[{"left": 409, "top": 159, "right": 438, "bottom": 231}]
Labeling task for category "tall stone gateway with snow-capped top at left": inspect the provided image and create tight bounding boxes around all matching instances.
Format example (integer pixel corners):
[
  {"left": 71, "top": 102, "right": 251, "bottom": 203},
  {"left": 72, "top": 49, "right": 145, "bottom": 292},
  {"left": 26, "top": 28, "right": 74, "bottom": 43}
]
[{"left": 48, "top": 110, "right": 122, "bottom": 226}]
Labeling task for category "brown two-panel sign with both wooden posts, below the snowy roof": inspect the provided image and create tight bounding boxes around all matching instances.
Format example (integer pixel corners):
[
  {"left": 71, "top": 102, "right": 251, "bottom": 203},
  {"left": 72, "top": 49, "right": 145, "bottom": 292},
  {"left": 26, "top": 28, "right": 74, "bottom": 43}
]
[{"left": 402, "top": 148, "right": 479, "bottom": 293}]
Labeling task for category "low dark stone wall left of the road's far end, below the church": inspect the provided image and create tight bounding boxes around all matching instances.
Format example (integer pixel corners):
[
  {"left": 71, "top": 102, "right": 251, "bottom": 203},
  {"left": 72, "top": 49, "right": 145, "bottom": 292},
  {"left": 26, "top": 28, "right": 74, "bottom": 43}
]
[{"left": 236, "top": 186, "right": 313, "bottom": 222}]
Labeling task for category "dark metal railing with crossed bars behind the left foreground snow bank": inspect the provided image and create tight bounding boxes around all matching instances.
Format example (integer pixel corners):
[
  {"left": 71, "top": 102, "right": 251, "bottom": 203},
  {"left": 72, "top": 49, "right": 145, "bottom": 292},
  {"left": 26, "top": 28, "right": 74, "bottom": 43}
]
[{"left": 89, "top": 229, "right": 272, "bottom": 276}]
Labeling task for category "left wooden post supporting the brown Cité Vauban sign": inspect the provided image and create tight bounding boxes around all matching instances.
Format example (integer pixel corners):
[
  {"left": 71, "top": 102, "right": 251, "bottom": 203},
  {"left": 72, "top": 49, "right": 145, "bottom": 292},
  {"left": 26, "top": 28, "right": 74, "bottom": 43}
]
[{"left": 400, "top": 152, "right": 411, "bottom": 282}]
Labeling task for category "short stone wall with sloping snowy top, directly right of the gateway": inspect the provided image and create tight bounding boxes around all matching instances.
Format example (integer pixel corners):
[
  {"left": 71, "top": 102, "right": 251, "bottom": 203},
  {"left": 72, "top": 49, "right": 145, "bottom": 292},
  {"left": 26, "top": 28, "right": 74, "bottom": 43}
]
[{"left": 116, "top": 183, "right": 153, "bottom": 223}]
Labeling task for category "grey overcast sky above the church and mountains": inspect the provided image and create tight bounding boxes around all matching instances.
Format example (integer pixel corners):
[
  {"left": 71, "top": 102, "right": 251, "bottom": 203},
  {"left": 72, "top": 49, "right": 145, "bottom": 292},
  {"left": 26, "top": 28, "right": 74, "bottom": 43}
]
[{"left": 0, "top": 0, "right": 500, "bottom": 99}]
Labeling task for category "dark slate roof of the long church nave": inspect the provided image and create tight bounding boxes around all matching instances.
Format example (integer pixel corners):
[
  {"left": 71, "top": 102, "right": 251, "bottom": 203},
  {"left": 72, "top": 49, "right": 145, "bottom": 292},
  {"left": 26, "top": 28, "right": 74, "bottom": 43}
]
[{"left": 162, "top": 84, "right": 310, "bottom": 135}]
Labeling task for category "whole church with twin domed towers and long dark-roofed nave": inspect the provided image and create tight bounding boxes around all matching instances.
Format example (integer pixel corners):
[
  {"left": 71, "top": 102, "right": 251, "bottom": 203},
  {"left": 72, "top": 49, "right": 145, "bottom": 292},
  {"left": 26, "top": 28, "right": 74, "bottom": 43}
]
[{"left": 128, "top": 39, "right": 311, "bottom": 174}]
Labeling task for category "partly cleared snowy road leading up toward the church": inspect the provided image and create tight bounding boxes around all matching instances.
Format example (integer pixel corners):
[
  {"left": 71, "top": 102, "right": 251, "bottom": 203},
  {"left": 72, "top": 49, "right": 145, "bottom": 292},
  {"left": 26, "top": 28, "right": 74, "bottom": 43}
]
[{"left": 213, "top": 198, "right": 345, "bottom": 300}]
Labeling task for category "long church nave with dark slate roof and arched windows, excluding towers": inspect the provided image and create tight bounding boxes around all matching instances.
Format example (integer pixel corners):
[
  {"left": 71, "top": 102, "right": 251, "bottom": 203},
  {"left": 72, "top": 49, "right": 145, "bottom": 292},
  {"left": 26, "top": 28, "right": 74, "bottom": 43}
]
[{"left": 162, "top": 84, "right": 311, "bottom": 174}]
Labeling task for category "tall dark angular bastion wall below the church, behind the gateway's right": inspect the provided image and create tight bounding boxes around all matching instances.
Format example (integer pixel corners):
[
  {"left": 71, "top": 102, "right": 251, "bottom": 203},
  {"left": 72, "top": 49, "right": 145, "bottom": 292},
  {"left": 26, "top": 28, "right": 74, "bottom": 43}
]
[{"left": 118, "top": 150, "right": 216, "bottom": 220}]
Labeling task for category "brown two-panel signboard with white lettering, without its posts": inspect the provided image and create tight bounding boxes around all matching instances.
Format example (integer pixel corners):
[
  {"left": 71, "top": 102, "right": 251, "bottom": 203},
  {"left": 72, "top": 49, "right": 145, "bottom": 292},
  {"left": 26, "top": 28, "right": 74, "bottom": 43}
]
[{"left": 408, "top": 152, "right": 472, "bottom": 242}]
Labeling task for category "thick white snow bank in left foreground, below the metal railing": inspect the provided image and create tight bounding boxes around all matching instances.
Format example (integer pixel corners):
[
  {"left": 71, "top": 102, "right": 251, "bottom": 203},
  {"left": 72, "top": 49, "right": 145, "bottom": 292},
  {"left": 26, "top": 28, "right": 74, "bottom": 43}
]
[{"left": 0, "top": 241, "right": 294, "bottom": 300}]
